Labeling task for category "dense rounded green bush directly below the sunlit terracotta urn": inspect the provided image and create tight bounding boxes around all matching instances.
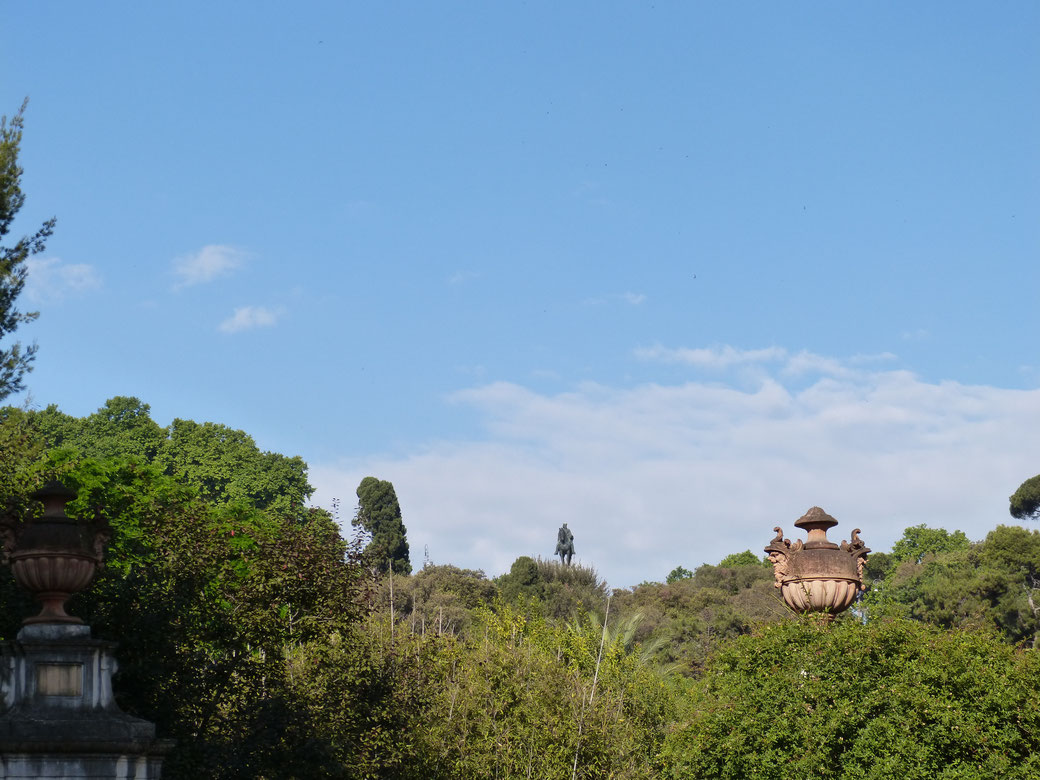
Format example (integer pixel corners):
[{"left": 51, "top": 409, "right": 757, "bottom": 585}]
[{"left": 660, "top": 616, "right": 1040, "bottom": 780}]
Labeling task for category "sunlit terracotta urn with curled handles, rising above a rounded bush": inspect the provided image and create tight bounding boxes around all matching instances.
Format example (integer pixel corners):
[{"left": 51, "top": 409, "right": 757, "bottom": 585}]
[{"left": 765, "top": 506, "right": 870, "bottom": 616}]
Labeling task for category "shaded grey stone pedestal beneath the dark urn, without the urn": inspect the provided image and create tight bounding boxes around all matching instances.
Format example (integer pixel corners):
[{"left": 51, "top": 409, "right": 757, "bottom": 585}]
[{"left": 0, "top": 623, "right": 173, "bottom": 780}]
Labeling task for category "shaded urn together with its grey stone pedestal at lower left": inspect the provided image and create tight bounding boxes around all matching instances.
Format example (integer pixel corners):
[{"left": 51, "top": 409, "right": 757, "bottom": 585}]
[{"left": 0, "top": 483, "right": 174, "bottom": 780}]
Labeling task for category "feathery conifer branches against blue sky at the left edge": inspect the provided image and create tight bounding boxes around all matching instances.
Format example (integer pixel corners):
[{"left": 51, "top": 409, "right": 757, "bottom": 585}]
[{"left": 0, "top": 99, "right": 55, "bottom": 399}]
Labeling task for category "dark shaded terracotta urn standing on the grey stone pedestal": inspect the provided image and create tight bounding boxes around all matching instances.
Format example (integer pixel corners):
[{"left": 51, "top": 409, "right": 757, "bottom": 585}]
[{"left": 0, "top": 480, "right": 110, "bottom": 625}]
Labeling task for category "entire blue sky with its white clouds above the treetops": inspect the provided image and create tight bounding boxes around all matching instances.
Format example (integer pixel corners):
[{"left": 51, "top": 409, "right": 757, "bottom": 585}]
[{"left": 0, "top": 2, "right": 1040, "bottom": 586}]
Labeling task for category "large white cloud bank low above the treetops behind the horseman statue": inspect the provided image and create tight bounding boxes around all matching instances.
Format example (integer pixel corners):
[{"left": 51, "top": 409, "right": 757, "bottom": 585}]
[{"left": 311, "top": 347, "right": 1040, "bottom": 587}]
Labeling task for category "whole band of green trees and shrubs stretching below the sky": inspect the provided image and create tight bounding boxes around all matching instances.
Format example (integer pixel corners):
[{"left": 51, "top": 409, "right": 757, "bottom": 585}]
[{"left": 0, "top": 398, "right": 1040, "bottom": 780}]
